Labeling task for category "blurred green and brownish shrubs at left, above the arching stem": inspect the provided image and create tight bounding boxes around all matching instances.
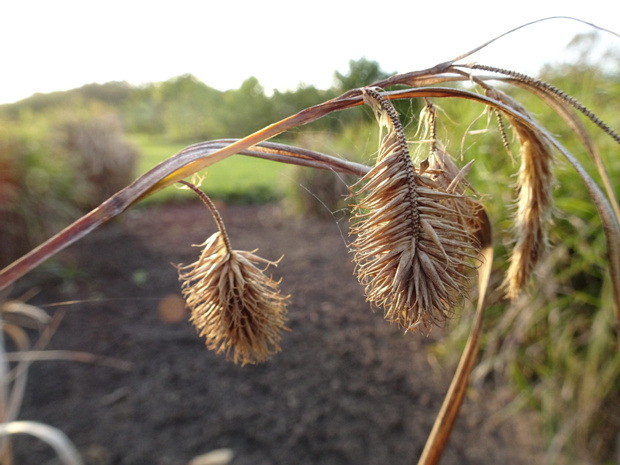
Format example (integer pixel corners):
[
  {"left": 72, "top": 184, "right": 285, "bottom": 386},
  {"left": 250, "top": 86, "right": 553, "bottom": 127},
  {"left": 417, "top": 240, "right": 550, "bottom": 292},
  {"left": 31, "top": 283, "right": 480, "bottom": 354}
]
[{"left": 0, "top": 106, "right": 138, "bottom": 264}]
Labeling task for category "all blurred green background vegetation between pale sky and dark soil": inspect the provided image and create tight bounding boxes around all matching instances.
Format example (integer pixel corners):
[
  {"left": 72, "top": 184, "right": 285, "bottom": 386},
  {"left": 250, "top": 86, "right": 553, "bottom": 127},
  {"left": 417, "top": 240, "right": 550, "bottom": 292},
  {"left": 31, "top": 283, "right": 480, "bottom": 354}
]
[{"left": 0, "top": 36, "right": 620, "bottom": 463}]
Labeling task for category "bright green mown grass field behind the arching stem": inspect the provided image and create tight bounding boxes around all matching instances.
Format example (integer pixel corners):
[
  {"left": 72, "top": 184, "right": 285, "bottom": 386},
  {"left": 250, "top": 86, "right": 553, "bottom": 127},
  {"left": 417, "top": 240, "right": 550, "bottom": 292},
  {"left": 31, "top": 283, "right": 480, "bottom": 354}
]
[{"left": 128, "top": 134, "right": 287, "bottom": 204}]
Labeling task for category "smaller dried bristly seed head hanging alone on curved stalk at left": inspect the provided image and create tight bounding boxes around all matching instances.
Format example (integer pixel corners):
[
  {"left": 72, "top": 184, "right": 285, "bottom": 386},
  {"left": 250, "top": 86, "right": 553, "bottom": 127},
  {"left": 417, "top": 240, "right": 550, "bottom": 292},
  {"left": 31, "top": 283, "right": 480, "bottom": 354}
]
[{"left": 177, "top": 182, "right": 288, "bottom": 365}]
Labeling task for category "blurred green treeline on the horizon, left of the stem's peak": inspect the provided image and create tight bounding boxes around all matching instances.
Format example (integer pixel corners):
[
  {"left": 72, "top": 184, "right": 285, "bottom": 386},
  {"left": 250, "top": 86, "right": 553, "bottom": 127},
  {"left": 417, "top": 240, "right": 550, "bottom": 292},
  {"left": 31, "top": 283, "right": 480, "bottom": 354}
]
[{"left": 0, "top": 58, "right": 387, "bottom": 142}]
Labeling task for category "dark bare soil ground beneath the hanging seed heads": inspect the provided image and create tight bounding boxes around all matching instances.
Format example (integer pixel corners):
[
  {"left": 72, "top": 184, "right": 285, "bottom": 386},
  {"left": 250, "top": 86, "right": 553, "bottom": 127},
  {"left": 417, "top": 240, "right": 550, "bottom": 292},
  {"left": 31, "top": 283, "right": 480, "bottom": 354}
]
[{"left": 9, "top": 203, "right": 544, "bottom": 465}]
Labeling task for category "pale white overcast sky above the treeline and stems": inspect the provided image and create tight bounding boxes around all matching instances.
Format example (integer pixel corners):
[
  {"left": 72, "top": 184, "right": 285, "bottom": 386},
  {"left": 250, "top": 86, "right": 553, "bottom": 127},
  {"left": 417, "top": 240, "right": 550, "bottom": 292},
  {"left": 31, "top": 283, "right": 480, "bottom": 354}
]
[{"left": 0, "top": 0, "right": 620, "bottom": 103}]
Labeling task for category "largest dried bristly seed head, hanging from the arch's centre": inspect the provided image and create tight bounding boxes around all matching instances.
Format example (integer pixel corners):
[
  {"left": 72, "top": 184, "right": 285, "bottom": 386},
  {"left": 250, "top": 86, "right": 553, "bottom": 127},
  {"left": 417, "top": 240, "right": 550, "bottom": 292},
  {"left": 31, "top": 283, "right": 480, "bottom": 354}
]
[{"left": 351, "top": 88, "right": 479, "bottom": 331}]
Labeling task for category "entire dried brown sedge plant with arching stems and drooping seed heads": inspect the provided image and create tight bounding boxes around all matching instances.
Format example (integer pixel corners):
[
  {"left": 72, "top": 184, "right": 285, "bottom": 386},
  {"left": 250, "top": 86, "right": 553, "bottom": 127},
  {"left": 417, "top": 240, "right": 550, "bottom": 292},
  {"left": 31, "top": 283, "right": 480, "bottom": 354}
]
[{"left": 0, "top": 17, "right": 620, "bottom": 465}]
